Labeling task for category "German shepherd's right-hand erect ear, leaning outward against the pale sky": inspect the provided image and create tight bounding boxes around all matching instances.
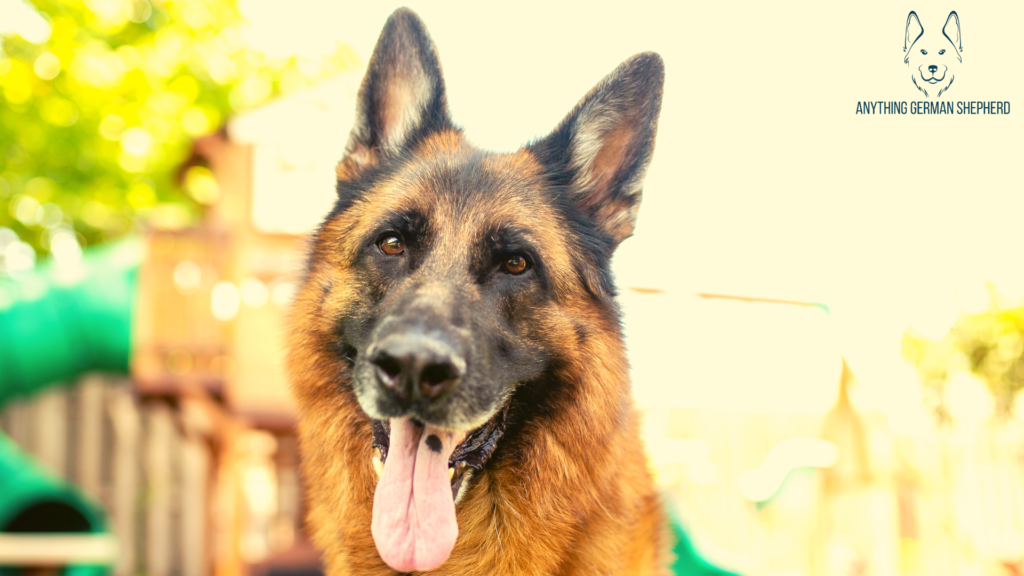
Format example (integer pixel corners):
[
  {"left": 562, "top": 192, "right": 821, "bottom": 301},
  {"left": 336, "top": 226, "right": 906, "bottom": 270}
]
[{"left": 530, "top": 52, "right": 665, "bottom": 245}]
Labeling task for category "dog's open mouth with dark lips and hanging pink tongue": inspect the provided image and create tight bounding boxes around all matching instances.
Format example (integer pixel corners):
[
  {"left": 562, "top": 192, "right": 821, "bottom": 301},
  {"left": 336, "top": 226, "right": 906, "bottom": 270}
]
[{"left": 371, "top": 403, "right": 508, "bottom": 572}]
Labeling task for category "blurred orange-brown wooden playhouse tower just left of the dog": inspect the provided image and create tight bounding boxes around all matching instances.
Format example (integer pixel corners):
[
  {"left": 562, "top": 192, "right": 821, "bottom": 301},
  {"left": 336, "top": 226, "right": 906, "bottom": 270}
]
[{"left": 132, "top": 74, "right": 358, "bottom": 576}]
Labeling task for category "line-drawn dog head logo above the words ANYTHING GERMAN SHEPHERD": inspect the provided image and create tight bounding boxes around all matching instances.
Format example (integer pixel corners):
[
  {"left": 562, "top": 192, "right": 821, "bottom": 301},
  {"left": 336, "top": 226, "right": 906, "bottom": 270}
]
[{"left": 903, "top": 10, "right": 964, "bottom": 97}]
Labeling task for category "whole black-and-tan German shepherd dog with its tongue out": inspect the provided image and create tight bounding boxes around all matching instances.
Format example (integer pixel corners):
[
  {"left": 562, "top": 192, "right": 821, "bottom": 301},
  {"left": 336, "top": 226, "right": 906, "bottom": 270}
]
[{"left": 288, "top": 9, "right": 671, "bottom": 576}]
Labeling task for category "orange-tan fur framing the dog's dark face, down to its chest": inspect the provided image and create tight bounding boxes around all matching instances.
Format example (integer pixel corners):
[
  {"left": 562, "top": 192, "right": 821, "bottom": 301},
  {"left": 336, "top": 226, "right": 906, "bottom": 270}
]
[{"left": 288, "top": 131, "right": 671, "bottom": 576}]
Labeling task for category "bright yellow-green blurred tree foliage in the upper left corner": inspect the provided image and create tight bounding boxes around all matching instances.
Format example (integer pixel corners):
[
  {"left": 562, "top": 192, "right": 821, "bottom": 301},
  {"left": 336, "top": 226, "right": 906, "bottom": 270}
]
[{"left": 0, "top": 0, "right": 355, "bottom": 274}]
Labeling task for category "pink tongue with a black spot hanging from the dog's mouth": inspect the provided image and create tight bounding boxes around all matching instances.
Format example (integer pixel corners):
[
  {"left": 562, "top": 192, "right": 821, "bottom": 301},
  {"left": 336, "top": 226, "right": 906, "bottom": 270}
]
[{"left": 370, "top": 418, "right": 465, "bottom": 572}]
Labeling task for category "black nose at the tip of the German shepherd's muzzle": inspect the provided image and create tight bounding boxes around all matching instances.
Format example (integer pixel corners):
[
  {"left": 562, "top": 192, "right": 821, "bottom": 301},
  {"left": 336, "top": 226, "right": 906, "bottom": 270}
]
[{"left": 370, "top": 335, "right": 466, "bottom": 400}]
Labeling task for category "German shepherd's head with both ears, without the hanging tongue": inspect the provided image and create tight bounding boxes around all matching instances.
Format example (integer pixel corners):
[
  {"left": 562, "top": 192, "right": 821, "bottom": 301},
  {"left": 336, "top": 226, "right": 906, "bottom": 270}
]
[{"left": 327, "top": 9, "right": 663, "bottom": 430}]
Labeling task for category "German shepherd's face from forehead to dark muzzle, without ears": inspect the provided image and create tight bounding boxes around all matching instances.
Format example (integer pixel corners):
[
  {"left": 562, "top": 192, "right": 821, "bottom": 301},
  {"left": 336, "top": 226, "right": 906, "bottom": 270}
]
[{"left": 340, "top": 154, "right": 553, "bottom": 429}]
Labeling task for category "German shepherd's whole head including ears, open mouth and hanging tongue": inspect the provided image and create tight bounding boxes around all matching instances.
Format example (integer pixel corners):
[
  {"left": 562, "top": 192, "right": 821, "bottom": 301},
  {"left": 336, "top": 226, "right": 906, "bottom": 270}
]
[{"left": 293, "top": 9, "right": 664, "bottom": 572}]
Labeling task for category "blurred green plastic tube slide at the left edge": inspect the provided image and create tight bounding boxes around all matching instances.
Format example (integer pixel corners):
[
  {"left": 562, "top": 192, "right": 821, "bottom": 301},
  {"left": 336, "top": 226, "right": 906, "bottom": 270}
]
[{"left": 0, "top": 239, "right": 142, "bottom": 576}]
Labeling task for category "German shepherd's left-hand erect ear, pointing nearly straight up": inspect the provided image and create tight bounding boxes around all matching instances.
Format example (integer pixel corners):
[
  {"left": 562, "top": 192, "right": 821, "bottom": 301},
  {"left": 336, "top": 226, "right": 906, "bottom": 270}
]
[{"left": 338, "top": 8, "right": 451, "bottom": 179}]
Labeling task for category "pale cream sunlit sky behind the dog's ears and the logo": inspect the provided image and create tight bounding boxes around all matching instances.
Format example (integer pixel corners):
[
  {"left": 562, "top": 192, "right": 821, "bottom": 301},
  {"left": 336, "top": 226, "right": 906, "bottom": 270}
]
[{"left": 234, "top": 0, "right": 1024, "bottom": 416}]
